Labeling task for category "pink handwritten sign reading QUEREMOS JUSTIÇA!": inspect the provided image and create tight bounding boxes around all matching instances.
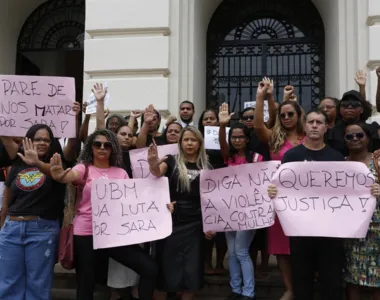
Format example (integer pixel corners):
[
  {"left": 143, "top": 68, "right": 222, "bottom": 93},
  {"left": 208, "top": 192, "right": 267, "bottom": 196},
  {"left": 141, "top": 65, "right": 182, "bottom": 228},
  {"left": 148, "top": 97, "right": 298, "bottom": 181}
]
[{"left": 272, "top": 162, "right": 376, "bottom": 238}]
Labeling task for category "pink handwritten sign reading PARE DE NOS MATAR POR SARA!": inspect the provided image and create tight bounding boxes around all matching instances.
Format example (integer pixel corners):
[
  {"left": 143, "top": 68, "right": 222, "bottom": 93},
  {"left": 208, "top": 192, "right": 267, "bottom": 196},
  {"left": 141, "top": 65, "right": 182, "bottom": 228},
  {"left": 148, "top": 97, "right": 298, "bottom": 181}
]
[{"left": 0, "top": 75, "right": 75, "bottom": 138}]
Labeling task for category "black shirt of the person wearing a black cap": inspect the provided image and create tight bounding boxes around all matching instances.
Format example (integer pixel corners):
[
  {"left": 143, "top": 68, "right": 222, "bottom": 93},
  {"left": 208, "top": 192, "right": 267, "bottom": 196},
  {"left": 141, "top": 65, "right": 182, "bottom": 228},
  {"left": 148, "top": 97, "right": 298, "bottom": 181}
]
[{"left": 325, "top": 120, "right": 380, "bottom": 156}]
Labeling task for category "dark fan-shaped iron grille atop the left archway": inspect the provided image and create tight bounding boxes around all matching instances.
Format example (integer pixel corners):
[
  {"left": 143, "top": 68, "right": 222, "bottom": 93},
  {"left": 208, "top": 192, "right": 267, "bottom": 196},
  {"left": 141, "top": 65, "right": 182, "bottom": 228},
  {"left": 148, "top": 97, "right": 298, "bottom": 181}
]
[{"left": 18, "top": 0, "right": 85, "bottom": 52}]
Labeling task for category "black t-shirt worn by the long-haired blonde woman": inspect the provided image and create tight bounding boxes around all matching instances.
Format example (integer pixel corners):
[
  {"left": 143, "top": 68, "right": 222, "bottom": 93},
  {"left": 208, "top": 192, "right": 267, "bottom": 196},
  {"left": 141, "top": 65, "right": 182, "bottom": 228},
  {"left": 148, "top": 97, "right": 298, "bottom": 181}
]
[{"left": 165, "top": 155, "right": 202, "bottom": 225}]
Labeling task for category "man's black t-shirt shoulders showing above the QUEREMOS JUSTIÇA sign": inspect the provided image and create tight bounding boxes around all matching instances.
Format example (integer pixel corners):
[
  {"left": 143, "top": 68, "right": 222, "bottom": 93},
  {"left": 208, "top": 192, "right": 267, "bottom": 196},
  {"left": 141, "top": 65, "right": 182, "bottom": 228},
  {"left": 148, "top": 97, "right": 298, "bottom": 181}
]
[{"left": 282, "top": 145, "right": 344, "bottom": 164}]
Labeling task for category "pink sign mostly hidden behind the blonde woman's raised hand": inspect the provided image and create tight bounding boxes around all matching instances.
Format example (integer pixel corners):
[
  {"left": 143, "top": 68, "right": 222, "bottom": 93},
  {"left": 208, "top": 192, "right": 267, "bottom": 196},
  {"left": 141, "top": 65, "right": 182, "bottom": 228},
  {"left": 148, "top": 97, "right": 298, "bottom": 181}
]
[{"left": 129, "top": 144, "right": 178, "bottom": 178}]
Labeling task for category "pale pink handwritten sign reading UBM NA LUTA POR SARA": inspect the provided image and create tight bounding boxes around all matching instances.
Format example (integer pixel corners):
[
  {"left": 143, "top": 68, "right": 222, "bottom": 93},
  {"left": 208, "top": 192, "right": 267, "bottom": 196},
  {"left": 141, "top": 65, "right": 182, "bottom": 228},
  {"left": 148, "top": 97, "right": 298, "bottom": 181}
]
[{"left": 91, "top": 177, "right": 172, "bottom": 249}]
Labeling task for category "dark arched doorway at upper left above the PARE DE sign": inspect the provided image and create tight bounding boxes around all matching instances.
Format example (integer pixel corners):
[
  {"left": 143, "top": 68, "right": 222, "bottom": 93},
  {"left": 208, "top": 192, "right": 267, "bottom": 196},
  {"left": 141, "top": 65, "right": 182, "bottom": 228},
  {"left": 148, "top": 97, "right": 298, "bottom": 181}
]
[{"left": 16, "top": 0, "right": 85, "bottom": 101}]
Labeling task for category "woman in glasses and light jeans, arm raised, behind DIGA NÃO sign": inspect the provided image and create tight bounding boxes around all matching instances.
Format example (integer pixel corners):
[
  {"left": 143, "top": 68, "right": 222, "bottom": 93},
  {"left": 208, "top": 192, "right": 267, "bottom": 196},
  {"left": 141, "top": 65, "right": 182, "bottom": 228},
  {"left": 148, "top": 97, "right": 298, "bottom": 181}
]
[{"left": 219, "top": 103, "right": 263, "bottom": 300}]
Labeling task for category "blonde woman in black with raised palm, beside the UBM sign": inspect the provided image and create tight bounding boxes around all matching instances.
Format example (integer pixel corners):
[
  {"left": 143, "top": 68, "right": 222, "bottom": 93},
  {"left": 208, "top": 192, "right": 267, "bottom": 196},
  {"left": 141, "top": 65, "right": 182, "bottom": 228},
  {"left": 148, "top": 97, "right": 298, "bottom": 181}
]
[{"left": 148, "top": 126, "right": 211, "bottom": 300}]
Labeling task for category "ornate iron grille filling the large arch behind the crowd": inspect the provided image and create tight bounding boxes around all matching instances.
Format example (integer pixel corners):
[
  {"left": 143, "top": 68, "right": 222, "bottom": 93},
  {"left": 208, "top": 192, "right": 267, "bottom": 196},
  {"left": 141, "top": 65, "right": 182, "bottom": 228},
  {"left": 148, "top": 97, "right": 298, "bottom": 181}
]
[{"left": 207, "top": 0, "right": 324, "bottom": 117}]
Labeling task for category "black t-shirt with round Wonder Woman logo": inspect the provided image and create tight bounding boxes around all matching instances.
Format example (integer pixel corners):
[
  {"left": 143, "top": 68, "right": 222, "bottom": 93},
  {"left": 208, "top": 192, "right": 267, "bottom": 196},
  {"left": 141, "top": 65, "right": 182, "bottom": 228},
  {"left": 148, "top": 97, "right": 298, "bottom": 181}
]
[{"left": 5, "top": 159, "right": 66, "bottom": 220}]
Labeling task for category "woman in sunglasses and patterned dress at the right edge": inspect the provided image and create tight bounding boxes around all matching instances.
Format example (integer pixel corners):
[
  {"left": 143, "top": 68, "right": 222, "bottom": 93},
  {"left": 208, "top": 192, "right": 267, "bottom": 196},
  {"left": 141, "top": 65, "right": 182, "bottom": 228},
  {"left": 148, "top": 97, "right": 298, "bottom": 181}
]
[{"left": 344, "top": 122, "right": 380, "bottom": 300}]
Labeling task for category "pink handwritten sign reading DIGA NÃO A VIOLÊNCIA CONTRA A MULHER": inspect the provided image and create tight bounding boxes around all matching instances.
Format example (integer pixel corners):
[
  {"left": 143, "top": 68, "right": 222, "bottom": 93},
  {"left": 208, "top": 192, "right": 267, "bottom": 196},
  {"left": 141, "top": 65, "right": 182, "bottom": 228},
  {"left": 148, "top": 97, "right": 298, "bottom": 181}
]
[{"left": 200, "top": 161, "right": 280, "bottom": 232}]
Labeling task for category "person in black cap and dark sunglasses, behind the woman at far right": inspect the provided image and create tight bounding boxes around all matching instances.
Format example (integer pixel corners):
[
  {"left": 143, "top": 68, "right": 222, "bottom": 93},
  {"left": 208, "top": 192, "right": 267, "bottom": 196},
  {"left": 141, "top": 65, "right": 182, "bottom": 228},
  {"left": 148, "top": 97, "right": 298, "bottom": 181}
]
[{"left": 326, "top": 90, "right": 380, "bottom": 156}]
